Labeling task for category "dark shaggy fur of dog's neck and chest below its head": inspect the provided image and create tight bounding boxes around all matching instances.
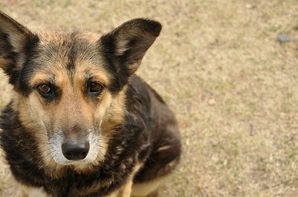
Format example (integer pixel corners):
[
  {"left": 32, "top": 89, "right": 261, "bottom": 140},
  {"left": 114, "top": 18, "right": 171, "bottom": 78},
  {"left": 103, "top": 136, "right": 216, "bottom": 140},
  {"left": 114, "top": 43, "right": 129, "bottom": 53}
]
[{"left": 1, "top": 106, "right": 150, "bottom": 197}]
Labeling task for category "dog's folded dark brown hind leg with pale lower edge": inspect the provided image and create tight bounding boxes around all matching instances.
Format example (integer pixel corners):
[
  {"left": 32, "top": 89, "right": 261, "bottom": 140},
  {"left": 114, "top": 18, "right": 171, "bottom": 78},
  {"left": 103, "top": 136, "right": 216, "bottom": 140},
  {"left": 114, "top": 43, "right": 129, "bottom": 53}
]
[{"left": 132, "top": 121, "right": 181, "bottom": 197}]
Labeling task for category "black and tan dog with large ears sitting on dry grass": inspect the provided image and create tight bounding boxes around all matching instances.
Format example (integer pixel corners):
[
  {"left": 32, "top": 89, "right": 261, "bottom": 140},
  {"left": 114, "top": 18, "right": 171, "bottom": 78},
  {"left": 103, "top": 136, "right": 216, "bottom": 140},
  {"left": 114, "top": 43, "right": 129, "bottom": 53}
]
[{"left": 0, "top": 12, "right": 181, "bottom": 197}]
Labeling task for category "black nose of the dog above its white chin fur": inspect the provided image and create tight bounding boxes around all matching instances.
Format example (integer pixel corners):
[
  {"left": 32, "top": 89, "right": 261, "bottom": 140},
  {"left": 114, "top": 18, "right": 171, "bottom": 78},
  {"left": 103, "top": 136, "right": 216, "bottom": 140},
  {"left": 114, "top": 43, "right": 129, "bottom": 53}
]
[{"left": 62, "top": 141, "right": 89, "bottom": 160}]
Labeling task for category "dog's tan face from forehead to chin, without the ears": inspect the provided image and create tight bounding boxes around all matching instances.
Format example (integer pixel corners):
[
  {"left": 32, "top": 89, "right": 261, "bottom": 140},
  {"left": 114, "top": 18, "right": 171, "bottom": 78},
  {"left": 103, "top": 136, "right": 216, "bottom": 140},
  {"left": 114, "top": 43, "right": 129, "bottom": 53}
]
[{"left": 23, "top": 33, "right": 116, "bottom": 164}]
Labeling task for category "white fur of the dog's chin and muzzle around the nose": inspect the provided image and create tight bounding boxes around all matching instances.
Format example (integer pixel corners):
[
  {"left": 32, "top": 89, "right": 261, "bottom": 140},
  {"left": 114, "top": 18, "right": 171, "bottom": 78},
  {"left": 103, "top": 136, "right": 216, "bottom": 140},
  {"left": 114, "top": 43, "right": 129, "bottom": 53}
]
[{"left": 49, "top": 131, "right": 100, "bottom": 165}]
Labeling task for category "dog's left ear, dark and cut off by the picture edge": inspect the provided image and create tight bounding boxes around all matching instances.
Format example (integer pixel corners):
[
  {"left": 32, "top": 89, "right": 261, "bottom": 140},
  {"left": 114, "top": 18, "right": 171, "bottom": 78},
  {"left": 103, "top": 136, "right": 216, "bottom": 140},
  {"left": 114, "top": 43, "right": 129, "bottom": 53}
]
[{"left": 0, "top": 12, "right": 38, "bottom": 85}]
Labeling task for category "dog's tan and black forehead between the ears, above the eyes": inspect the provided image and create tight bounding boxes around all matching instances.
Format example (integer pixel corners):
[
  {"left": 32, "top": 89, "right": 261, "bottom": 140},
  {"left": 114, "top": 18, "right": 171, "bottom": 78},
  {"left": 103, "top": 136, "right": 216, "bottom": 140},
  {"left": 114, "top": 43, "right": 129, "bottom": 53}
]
[{"left": 27, "top": 32, "right": 109, "bottom": 84}]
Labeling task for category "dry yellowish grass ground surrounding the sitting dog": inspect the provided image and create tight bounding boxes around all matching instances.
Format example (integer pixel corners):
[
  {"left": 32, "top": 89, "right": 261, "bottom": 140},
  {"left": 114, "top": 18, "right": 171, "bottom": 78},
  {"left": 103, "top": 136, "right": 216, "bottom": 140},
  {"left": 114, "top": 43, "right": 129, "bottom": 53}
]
[{"left": 0, "top": 0, "right": 298, "bottom": 197}]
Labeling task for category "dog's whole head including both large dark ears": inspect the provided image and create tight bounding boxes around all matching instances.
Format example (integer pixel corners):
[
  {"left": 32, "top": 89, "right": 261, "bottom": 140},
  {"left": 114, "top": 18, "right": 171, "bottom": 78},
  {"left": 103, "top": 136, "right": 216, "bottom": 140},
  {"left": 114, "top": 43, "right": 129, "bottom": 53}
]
[{"left": 0, "top": 10, "right": 161, "bottom": 166}]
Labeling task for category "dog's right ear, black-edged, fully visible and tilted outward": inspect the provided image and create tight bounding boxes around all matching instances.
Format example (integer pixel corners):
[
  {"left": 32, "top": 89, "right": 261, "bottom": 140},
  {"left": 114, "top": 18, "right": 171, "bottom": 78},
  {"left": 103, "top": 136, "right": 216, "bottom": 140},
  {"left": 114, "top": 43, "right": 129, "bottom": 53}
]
[{"left": 100, "top": 18, "right": 161, "bottom": 75}]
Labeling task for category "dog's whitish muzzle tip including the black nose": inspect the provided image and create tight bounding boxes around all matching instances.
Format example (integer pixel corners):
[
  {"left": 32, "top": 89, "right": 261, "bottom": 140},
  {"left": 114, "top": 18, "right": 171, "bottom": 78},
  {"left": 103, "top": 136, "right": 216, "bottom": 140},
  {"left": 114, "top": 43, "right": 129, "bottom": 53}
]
[{"left": 48, "top": 131, "right": 102, "bottom": 165}]
